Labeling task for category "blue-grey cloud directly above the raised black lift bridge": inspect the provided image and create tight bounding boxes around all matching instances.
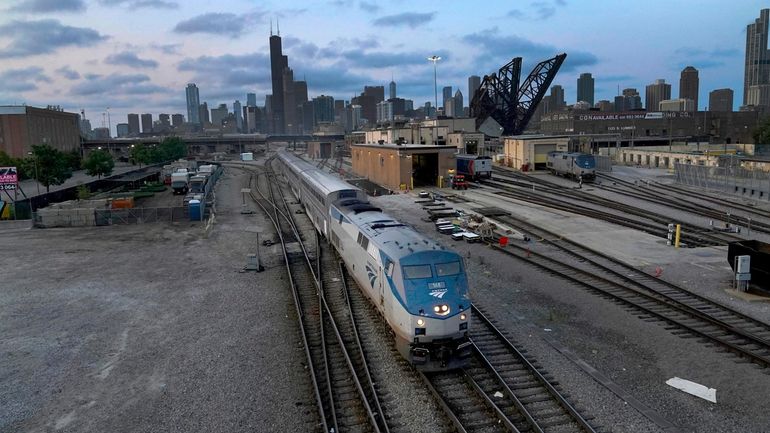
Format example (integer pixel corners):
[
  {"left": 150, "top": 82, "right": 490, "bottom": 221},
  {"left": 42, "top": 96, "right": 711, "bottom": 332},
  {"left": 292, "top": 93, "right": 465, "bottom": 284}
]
[{"left": 462, "top": 27, "right": 598, "bottom": 71}]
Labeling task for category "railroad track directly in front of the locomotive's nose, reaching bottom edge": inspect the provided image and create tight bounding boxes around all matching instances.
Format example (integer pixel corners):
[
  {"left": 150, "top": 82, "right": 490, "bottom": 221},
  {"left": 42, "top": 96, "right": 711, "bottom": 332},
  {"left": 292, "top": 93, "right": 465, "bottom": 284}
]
[{"left": 416, "top": 305, "right": 596, "bottom": 433}]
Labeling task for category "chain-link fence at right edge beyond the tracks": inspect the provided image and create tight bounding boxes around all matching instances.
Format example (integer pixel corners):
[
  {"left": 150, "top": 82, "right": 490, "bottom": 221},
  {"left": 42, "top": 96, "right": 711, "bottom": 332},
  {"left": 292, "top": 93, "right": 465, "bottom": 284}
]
[{"left": 674, "top": 164, "right": 770, "bottom": 200}]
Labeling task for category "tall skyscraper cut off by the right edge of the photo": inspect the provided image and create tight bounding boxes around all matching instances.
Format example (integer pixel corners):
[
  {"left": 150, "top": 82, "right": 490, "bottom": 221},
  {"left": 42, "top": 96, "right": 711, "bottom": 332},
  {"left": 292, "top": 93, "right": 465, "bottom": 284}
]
[{"left": 743, "top": 9, "right": 770, "bottom": 105}]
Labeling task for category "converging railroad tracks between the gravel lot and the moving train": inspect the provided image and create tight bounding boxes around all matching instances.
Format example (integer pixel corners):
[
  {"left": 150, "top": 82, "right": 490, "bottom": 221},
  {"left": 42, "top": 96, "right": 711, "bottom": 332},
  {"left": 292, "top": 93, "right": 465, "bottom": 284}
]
[{"left": 250, "top": 160, "right": 389, "bottom": 432}]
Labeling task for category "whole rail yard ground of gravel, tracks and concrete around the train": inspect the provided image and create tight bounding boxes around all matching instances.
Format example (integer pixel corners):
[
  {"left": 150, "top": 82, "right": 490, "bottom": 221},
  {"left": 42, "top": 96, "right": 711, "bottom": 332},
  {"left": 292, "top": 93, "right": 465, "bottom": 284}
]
[{"left": 0, "top": 147, "right": 770, "bottom": 432}]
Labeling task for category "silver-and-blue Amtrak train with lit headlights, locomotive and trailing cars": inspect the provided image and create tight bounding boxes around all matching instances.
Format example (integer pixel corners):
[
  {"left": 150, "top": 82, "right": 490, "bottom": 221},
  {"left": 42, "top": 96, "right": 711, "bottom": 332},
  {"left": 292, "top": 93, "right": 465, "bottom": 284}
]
[{"left": 278, "top": 152, "right": 471, "bottom": 371}]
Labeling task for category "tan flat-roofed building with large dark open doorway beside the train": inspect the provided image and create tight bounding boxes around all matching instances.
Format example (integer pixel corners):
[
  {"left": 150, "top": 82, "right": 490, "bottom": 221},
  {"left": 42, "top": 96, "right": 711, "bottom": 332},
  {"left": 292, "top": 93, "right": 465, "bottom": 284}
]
[{"left": 351, "top": 144, "right": 457, "bottom": 190}]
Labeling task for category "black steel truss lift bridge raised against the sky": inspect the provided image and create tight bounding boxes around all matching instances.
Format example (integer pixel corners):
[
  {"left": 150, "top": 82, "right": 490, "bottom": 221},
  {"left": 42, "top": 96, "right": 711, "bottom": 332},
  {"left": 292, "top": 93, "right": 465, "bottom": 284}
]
[{"left": 470, "top": 53, "right": 567, "bottom": 137}]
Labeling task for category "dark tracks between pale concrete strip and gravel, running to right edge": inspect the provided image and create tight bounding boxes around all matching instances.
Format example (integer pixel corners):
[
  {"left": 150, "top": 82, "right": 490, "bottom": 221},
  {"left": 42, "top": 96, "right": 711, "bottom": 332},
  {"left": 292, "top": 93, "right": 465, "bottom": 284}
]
[{"left": 488, "top": 213, "right": 770, "bottom": 367}]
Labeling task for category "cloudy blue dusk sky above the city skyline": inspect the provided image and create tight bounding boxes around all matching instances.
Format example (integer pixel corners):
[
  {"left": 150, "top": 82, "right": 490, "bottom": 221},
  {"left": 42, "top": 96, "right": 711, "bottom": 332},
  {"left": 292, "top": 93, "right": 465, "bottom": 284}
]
[{"left": 0, "top": 0, "right": 768, "bottom": 131}]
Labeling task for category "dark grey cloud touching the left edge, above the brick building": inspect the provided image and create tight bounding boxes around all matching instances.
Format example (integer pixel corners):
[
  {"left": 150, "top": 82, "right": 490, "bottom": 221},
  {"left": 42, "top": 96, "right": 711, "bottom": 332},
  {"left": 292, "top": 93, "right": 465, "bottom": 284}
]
[{"left": 0, "top": 20, "right": 108, "bottom": 58}]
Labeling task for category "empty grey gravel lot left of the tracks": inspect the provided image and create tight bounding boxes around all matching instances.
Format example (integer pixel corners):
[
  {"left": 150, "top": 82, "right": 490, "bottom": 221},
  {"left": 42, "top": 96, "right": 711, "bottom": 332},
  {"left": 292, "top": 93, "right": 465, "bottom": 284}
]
[{"left": 0, "top": 166, "right": 314, "bottom": 432}]
